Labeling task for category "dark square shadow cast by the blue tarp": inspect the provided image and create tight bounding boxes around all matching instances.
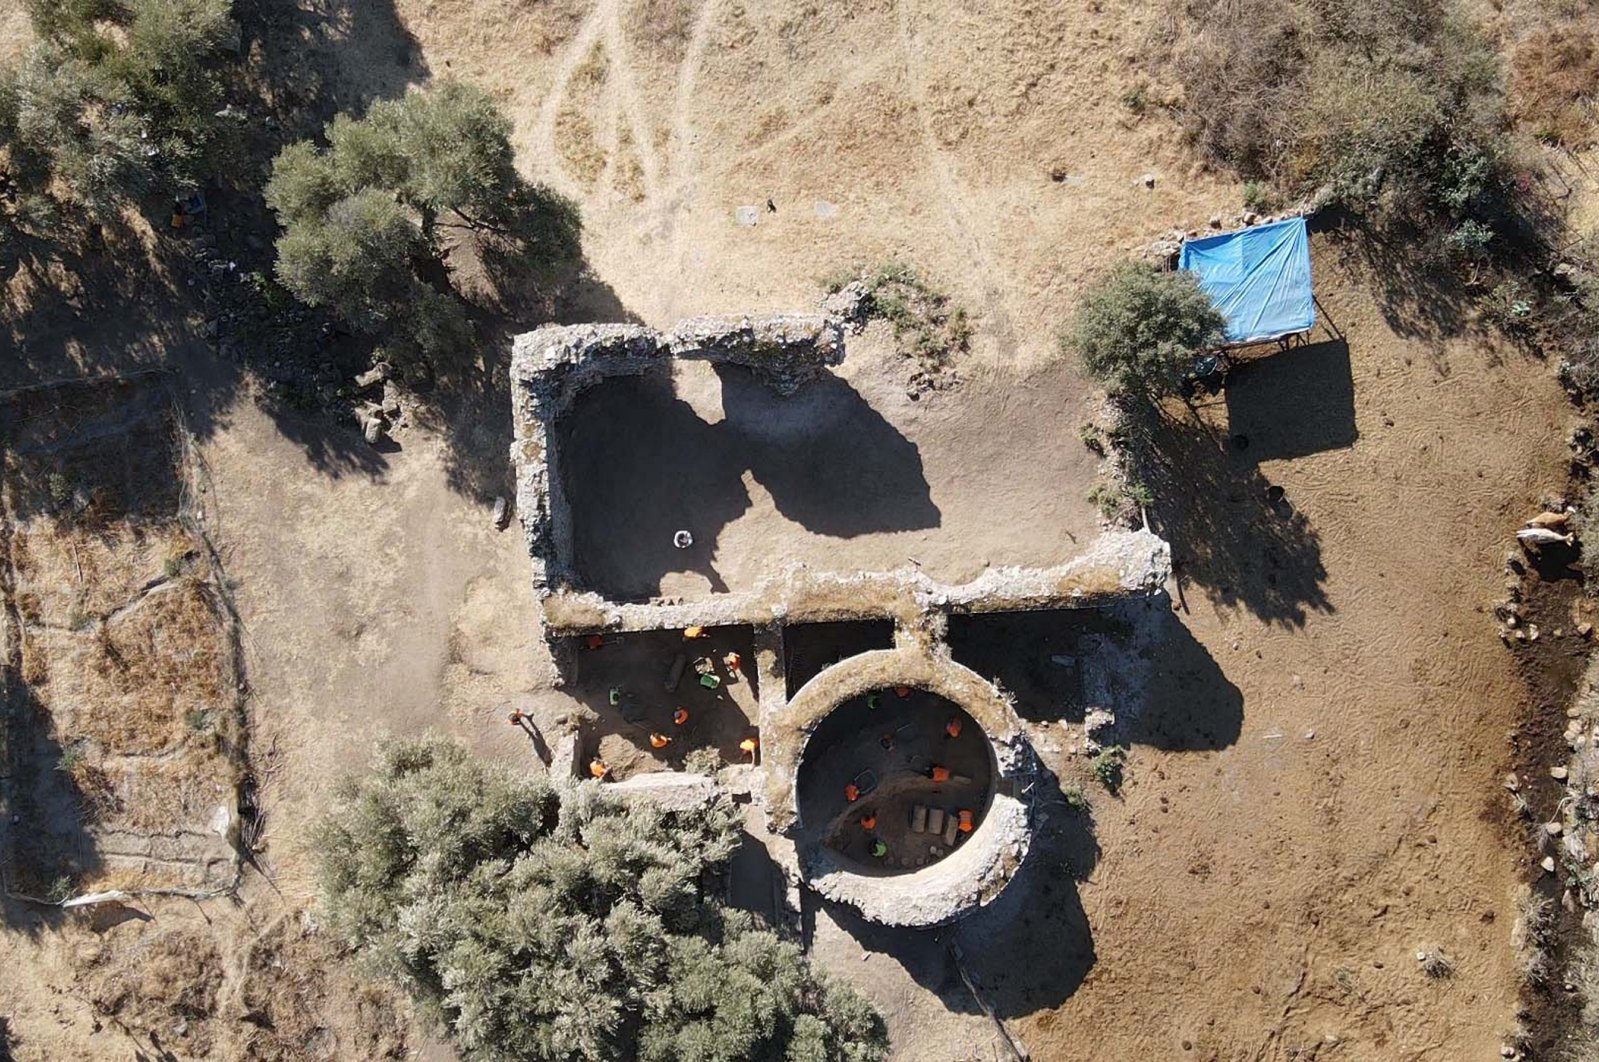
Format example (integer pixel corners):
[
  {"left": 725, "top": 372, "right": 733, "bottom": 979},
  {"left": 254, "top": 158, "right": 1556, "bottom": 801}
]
[{"left": 1226, "top": 339, "right": 1359, "bottom": 462}]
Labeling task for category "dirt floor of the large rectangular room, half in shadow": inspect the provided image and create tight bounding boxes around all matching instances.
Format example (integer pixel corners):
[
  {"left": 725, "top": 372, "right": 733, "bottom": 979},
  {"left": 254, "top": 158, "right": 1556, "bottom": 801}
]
[{"left": 561, "top": 342, "right": 1097, "bottom": 600}]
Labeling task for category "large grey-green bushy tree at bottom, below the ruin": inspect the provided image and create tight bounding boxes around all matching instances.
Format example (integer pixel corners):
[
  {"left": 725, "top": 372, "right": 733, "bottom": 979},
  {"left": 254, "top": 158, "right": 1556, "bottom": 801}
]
[{"left": 320, "top": 742, "right": 886, "bottom": 1062}]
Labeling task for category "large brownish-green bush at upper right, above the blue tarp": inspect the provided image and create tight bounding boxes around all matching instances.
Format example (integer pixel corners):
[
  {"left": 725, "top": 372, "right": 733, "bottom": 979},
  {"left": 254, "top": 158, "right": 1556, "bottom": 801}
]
[{"left": 1174, "top": 0, "right": 1506, "bottom": 221}]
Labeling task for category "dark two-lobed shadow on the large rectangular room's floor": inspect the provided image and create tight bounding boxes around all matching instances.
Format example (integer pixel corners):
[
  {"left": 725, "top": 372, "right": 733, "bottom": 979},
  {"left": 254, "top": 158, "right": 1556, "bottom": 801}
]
[{"left": 556, "top": 366, "right": 940, "bottom": 600}]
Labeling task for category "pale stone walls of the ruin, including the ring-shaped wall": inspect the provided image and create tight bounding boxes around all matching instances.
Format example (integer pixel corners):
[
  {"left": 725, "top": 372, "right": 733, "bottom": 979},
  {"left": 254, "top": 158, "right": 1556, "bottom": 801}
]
[{"left": 512, "top": 307, "right": 1170, "bottom": 924}]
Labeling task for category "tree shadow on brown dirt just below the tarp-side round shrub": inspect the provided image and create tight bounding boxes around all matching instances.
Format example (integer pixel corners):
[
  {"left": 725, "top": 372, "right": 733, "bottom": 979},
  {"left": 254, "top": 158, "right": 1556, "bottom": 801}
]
[{"left": 1127, "top": 406, "right": 1332, "bottom": 627}]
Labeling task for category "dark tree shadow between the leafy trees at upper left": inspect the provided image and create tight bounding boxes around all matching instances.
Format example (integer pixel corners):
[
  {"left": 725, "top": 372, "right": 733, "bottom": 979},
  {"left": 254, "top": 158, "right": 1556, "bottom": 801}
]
[{"left": 0, "top": 0, "right": 429, "bottom": 475}]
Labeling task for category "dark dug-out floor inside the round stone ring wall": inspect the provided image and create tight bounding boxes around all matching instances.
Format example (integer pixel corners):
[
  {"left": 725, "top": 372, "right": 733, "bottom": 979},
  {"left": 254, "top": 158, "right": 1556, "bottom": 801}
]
[{"left": 798, "top": 689, "right": 995, "bottom": 873}]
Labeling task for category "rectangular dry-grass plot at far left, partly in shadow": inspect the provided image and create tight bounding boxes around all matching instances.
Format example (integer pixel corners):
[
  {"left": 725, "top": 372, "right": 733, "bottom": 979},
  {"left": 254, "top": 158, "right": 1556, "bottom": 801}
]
[{"left": 0, "top": 376, "right": 240, "bottom": 894}]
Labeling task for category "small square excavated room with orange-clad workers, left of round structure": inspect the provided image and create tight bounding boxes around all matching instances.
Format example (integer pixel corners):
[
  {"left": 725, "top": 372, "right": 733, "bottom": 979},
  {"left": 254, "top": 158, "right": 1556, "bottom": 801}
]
[{"left": 569, "top": 627, "right": 760, "bottom": 777}]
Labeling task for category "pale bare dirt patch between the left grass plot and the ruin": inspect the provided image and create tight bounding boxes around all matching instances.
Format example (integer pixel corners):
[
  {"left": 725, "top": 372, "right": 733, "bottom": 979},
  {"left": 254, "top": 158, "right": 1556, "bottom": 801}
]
[{"left": 206, "top": 390, "right": 556, "bottom": 900}]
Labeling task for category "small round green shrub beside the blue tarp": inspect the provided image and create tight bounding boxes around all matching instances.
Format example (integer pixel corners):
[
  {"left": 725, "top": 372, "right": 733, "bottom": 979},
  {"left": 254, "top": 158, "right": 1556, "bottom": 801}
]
[{"left": 1062, "top": 262, "right": 1226, "bottom": 397}]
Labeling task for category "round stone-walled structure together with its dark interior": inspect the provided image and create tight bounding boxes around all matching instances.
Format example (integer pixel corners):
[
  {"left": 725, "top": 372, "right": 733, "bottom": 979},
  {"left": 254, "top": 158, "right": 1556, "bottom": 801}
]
[{"left": 763, "top": 648, "right": 1036, "bottom": 926}]
